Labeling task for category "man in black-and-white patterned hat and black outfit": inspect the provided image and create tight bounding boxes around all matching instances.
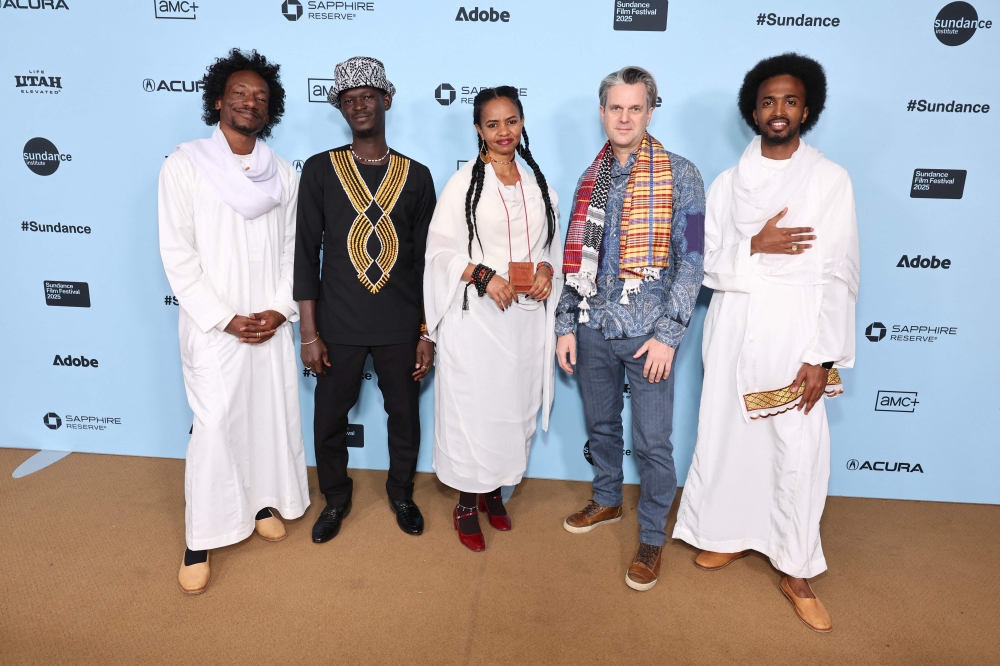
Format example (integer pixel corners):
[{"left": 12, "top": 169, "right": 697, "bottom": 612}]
[{"left": 293, "top": 57, "right": 436, "bottom": 543}]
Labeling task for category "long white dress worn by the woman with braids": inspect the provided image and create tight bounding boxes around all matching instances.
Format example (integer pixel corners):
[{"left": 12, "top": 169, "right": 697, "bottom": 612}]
[{"left": 424, "top": 162, "right": 562, "bottom": 493}]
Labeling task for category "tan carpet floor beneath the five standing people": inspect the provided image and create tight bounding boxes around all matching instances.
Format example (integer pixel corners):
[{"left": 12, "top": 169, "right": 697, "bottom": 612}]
[{"left": 0, "top": 449, "right": 1000, "bottom": 665}]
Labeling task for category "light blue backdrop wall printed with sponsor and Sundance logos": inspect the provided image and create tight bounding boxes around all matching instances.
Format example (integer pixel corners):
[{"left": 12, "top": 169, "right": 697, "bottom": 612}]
[{"left": 0, "top": 0, "right": 1000, "bottom": 503}]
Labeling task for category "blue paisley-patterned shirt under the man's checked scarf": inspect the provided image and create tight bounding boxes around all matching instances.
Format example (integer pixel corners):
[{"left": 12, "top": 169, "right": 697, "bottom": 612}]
[{"left": 556, "top": 153, "right": 705, "bottom": 349}]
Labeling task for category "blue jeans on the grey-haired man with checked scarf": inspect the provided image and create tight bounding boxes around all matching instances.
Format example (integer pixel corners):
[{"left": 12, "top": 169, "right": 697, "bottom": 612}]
[{"left": 576, "top": 326, "right": 677, "bottom": 546}]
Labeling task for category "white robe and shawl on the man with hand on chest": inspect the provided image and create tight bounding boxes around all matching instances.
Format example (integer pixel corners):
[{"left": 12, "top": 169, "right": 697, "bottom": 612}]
[{"left": 673, "top": 140, "right": 858, "bottom": 578}]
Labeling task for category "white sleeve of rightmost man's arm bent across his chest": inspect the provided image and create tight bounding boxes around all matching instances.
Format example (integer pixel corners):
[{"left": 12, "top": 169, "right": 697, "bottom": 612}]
[{"left": 702, "top": 173, "right": 760, "bottom": 293}]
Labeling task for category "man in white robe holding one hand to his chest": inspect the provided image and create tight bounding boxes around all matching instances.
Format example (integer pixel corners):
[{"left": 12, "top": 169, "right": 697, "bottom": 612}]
[{"left": 673, "top": 53, "right": 859, "bottom": 632}]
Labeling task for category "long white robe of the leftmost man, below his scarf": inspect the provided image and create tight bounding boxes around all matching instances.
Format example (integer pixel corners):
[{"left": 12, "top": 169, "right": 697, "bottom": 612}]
[{"left": 159, "top": 144, "right": 309, "bottom": 550}]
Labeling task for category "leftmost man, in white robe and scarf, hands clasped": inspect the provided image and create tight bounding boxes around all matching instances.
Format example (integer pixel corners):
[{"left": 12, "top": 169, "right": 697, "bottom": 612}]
[{"left": 159, "top": 49, "right": 309, "bottom": 594}]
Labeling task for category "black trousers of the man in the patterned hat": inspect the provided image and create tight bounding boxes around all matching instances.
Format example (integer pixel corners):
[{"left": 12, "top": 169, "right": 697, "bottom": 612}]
[{"left": 313, "top": 340, "right": 420, "bottom": 506}]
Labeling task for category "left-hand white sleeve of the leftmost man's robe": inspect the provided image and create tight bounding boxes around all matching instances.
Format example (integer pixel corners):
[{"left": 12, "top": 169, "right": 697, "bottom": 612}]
[{"left": 158, "top": 151, "right": 236, "bottom": 333}]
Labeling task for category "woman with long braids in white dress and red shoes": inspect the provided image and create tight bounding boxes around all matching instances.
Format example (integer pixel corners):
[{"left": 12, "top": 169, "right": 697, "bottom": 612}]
[{"left": 424, "top": 86, "right": 562, "bottom": 551}]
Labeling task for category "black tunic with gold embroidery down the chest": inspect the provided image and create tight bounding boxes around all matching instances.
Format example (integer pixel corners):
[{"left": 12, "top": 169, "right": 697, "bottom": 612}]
[{"left": 293, "top": 146, "right": 436, "bottom": 346}]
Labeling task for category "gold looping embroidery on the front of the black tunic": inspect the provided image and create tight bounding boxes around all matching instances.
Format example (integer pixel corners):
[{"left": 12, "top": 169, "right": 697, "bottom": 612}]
[{"left": 330, "top": 150, "right": 410, "bottom": 294}]
